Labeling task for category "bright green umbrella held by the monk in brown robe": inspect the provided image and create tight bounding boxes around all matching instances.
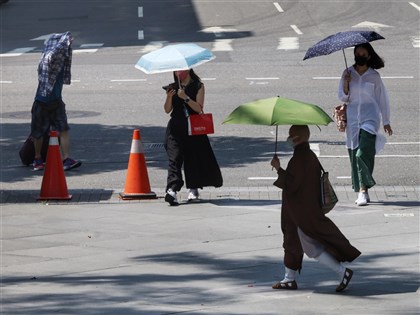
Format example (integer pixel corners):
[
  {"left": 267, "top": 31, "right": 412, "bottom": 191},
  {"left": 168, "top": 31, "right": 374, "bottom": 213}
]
[{"left": 223, "top": 97, "right": 333, "bottom": 152}]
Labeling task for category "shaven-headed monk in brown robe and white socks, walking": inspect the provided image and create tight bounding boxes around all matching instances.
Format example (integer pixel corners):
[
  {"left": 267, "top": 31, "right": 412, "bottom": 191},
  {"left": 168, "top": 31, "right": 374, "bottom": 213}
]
[{"left": 271, "top": 125, "right": 361, "bottom": 292}]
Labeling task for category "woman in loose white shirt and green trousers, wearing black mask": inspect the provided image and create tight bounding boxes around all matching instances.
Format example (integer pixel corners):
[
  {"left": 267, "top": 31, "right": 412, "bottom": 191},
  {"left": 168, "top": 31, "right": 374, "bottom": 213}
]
[{"left": 338, "top": 43, "right": 392, "bottom": 206}]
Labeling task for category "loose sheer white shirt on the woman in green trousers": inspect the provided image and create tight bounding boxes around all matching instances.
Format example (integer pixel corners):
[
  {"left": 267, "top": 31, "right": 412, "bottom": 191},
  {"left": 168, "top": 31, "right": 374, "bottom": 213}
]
[{"left": 338, "top": 66, "right": 390, "bottom": 152}]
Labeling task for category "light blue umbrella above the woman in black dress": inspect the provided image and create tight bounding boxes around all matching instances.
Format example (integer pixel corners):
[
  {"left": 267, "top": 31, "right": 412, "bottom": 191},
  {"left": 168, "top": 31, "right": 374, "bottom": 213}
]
[{"left": 135, "top": 43, "right": 216, "bottom": 74}]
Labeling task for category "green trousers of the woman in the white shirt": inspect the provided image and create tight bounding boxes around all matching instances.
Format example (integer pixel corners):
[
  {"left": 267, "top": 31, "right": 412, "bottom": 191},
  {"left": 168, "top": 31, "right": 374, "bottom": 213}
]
[{"left": 348, "top": 129, "right": 376, "bottom": 192}]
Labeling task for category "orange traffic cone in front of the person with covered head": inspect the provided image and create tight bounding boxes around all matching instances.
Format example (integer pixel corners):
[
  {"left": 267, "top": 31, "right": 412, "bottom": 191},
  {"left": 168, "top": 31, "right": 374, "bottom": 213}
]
[{"left": 38, "top": 131, "right": 72, "bottom": 200}]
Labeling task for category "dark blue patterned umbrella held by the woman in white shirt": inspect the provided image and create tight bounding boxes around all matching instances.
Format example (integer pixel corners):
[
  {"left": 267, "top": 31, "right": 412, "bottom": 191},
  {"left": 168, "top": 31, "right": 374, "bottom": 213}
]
[{"left": 303, "top": 31, "right": 385, "bottom": 68}]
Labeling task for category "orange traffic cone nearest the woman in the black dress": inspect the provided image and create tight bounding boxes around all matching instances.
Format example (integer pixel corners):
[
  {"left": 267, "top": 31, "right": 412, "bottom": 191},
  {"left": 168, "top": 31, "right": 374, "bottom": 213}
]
[{"left": 120, "top": 129, "right": 156, "bottom": 199}]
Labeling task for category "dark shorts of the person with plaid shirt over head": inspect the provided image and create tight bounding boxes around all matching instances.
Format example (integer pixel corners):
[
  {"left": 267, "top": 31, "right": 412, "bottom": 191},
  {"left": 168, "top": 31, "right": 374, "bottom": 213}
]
[{"left": 31, "top": 100, "right": 70, "bottom": 139}]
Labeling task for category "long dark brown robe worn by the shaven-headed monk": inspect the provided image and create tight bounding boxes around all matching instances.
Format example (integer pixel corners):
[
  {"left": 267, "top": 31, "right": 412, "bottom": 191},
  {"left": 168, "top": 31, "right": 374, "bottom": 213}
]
[{"left": 274, "top": 142, "right": 361, "bottom": 270}]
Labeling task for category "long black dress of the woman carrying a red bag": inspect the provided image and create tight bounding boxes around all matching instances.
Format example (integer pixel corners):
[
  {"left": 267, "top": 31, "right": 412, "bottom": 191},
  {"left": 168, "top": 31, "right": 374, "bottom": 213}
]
[{"left": 165, "top": 81, "right": 223, "bottom": 191}]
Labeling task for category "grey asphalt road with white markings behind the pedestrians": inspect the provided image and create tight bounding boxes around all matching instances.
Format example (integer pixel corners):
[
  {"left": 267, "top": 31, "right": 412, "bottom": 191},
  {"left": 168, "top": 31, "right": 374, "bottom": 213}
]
[{"left": 0, "top": 0, "right": 420, "bottom": 189}]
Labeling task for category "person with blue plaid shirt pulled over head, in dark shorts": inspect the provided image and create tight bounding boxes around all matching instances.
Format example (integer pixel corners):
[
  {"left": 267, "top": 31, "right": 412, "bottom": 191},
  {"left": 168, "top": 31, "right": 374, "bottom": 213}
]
[{"left": 31, "top": 32, "right": 82, "bottom": 171}]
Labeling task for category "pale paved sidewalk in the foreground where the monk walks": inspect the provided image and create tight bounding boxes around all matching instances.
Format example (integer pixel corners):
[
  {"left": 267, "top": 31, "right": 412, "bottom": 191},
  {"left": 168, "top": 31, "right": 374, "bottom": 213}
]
[{"left": 0, "top": 187, "right": 420, "bottom": 315}]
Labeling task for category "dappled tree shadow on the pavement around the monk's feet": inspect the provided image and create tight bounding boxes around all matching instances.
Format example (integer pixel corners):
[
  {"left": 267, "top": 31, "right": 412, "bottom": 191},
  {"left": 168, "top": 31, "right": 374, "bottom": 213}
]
[{"left": 2, "top": 252, "right": 418, "bottom": 315}]
